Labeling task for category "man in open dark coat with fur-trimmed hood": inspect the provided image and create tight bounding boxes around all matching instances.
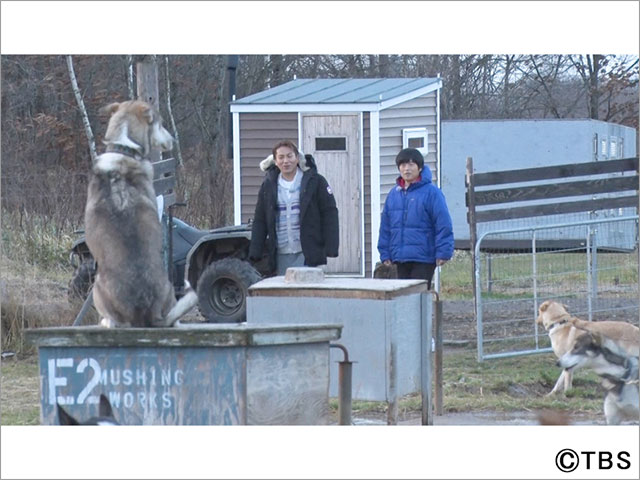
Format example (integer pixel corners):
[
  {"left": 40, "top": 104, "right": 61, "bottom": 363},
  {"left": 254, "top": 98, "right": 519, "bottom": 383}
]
[{"left": 249, "top": 140, "right": 339, "bottom": 275}]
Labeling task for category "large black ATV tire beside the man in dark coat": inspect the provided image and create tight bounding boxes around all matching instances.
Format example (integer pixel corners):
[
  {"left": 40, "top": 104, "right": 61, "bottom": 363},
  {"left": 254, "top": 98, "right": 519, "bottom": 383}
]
[{"left": 197, "top": 258, "right": 262, "bottom": 323}]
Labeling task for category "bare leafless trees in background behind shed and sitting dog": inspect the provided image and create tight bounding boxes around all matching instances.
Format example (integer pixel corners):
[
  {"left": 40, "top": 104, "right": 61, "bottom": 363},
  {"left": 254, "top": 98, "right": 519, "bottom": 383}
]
[{"left": 1, "top": 55, "right": 638, "bottom": 228}]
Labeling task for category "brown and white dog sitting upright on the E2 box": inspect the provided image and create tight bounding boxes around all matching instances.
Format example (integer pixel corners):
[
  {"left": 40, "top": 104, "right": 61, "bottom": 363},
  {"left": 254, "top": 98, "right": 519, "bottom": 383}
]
[{"left": 85, "top": 101, "right": 198, "bottom": 327}]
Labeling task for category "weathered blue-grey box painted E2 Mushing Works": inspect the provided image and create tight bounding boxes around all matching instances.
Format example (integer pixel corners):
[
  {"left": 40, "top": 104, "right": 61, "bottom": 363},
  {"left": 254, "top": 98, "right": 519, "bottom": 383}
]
[{"left": 27, "top": 324, "right": 341, "bottom": 425}]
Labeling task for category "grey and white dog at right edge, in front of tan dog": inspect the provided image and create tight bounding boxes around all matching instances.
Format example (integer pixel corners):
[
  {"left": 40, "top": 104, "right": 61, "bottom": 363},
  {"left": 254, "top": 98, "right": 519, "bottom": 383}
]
[{"left": 558, "top": 332, "right": 640, "bottom": 425}]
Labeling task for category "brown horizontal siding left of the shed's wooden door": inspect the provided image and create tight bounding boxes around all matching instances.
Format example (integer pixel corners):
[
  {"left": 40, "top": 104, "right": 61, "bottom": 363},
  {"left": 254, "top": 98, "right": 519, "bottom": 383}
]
[{"left": 240, "top": 112, "right": 298, "bottom": 223}]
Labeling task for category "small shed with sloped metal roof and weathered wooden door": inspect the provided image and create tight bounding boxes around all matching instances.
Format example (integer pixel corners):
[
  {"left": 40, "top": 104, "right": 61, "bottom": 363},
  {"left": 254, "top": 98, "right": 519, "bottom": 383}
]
[{"left": 231, "top": 78, "right": 442, "bottom": 277}]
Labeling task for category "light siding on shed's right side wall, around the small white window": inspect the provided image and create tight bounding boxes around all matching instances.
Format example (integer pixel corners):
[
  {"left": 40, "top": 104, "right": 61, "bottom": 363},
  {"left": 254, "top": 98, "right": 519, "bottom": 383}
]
[{"left": 380, "top": 92, "right": 438, "bottom": 210}]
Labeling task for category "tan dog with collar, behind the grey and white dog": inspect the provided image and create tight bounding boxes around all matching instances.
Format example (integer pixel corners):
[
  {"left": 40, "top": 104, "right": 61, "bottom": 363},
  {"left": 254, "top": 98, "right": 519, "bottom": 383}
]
[{"left": 536, "top": 300, "right": 640, "bottom": 395}]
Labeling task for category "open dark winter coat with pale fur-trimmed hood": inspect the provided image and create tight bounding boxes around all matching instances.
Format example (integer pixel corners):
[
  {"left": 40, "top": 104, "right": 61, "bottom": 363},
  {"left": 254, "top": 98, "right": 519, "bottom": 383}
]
[{"left": 249, "top": 155, "right": 339, "bottom": 273}]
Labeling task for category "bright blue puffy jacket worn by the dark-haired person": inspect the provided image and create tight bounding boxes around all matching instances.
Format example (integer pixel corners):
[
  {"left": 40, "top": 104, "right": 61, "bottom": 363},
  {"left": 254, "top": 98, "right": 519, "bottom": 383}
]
[{"left": 378, "top": 165, "right": 453, "bottom": 263}]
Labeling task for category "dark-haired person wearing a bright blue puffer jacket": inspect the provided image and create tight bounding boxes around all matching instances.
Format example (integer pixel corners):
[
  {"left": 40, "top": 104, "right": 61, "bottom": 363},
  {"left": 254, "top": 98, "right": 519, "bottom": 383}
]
[{"left": 378, "top": 148, "right": 453, "bottom": 289}]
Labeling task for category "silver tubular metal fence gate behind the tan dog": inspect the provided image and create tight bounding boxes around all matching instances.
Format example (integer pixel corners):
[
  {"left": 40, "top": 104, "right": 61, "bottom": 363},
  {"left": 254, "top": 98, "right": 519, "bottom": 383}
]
[{"left": 474, "top": 215, "right": 640, "bottom": 361}]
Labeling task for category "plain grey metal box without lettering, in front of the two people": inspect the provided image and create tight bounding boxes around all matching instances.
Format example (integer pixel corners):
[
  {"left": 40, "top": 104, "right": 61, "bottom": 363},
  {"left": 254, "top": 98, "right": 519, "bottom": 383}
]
[{"left": 247, "top": 276, "right": 433, "bottom": 402}]
